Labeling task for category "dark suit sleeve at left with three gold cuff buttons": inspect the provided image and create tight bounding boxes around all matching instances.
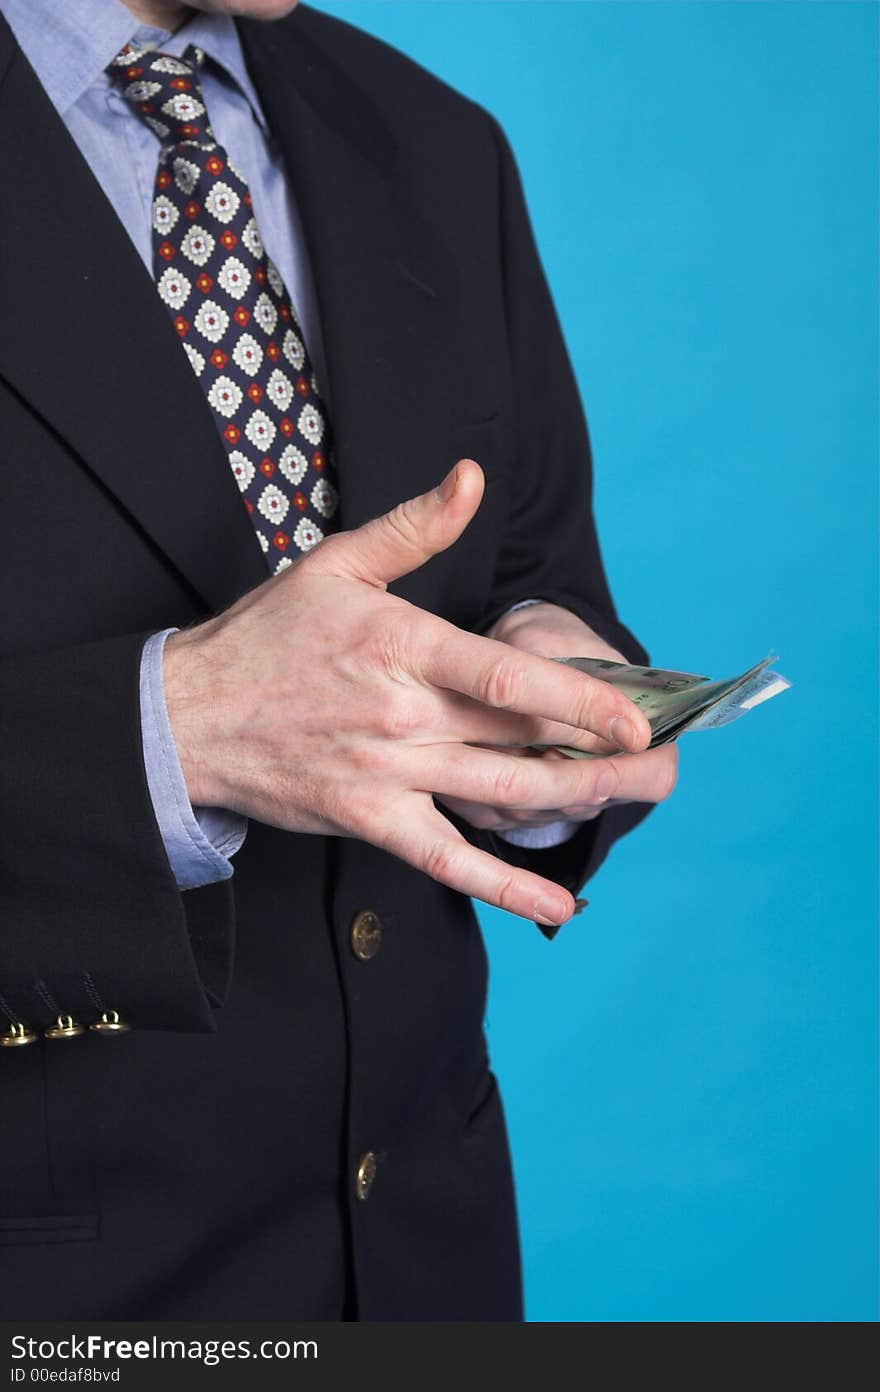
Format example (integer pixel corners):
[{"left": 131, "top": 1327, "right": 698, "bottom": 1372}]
[{"left": 0, "top": 633, "right": 234, "bottom": 1031}]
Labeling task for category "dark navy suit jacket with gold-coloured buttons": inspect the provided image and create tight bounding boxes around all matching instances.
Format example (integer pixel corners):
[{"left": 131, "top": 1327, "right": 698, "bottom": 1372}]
[{"left": 0, "top": 6, "right": 646, "bottom": 1320}]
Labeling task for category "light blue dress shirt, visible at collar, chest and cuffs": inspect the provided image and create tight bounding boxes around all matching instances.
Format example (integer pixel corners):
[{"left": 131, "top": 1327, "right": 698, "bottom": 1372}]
[{"left": 0, "top": 0, "right": 576, "bottom": 889}]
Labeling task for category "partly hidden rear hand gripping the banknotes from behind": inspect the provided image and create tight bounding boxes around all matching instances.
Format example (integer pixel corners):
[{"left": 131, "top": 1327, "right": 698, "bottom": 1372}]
[{"left": 441, "top": 603, "right": 678, "bottom": 831}]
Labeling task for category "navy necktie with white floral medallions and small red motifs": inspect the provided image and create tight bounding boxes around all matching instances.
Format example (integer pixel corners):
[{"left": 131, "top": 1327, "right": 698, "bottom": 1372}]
[{"left": 107, "top": 45, "right": 338, "bottom": 572}]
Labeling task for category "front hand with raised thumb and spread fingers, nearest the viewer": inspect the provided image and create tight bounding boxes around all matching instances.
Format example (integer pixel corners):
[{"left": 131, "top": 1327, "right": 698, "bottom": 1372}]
[{"left": 164, "top": 459, "right": 650, "bottom": 926}]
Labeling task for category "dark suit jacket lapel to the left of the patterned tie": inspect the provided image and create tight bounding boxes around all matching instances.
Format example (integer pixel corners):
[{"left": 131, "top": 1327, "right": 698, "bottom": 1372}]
[{"left": 0, "top": 18, "right": 266, "bottom": 610}]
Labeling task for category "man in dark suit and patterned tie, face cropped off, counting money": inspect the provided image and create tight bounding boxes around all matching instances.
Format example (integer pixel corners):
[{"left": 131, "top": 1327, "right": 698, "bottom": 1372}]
[{"left": 0, "top": 0, "right": 674, "bottom": 1320}]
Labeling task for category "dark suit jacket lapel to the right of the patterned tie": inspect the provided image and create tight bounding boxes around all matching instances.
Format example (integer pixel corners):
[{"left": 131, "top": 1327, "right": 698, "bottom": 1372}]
[{"left": 239, "top": 13, "right": 465, "bottom": 528}]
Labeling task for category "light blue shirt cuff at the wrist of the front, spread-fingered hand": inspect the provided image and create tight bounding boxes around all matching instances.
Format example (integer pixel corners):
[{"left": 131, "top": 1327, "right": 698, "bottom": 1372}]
[{"left": 141, "top": 628, "right": 248, "bottom": 889}]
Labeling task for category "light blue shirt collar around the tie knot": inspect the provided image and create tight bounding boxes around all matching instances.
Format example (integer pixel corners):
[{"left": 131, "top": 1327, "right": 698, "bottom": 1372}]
[{"left": 0, "top": 0, "right": 266, "bottom": 128}]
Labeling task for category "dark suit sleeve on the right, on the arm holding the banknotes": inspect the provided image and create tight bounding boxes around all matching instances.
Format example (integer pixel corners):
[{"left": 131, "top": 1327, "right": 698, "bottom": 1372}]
[{"left": 468, "top": 117, "right": 650, "bottom": 937}]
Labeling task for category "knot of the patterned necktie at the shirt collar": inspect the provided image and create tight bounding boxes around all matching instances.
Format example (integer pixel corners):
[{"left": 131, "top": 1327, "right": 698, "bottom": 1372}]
[{"left": 107, "top": 43, "right": 214, "bottom": 145}]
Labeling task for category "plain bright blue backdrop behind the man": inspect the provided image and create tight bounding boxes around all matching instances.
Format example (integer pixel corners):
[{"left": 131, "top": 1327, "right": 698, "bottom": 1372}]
[{"left": 314, "top": 0, "right": 877, "bottom": 1321}]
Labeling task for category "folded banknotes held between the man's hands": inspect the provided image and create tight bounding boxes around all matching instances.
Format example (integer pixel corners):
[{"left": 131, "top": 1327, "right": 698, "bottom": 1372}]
[{"left": 554, "top": 657, "right": 791, "bottom": 759}]
